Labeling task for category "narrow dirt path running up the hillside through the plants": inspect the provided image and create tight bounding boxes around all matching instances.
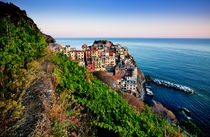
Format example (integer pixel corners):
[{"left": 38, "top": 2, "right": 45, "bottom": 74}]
[{"left": 8, "top": 59, "right": 54, "bottom": 137}]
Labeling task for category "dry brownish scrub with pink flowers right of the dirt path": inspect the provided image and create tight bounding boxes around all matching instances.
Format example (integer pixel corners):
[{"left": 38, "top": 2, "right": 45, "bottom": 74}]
[{"left": 50, "top": 89, "right": 95, "bottom": 137}]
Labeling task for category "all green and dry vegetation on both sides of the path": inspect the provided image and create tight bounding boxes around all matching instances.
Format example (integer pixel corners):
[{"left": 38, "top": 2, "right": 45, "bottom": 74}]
[{"left": 0, "top": 12, "right": 199, "bottom": 136}]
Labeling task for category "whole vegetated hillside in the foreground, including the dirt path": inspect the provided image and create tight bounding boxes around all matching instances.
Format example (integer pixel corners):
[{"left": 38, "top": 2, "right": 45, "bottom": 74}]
[{"left": 0, "top": 2, "right": 193, "bottom": 137}]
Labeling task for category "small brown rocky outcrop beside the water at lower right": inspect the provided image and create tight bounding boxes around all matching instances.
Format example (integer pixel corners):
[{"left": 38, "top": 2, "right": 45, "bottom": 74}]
[{"left": 152, "top": 104, "right": 177, "bottom": 123}]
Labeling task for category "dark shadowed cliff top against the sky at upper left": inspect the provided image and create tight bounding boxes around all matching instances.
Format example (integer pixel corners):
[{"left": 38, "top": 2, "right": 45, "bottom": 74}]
[{"left": 0, "top": 1, "right": 55, "bottom": 43}]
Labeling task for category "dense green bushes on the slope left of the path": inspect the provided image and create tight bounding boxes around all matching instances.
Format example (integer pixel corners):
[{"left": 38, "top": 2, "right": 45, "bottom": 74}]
[{"left": 0, "top": 17, "right": 47, "bottom": 94}]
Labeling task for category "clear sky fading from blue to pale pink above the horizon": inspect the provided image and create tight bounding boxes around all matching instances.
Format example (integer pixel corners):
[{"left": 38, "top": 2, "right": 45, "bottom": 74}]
[{"left": 2, "top": 0, "right": 210, "bottom": 38}]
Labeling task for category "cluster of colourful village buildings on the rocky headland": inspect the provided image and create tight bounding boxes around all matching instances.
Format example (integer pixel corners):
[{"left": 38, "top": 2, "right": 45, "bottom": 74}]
[{"left": 48, "top": 40, "right": 139, "bottom": 96}]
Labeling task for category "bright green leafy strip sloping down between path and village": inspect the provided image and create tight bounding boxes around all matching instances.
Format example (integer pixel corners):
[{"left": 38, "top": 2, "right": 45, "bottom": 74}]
[{"left": 52, "top": 53, "right": 180, "bottom": 136}]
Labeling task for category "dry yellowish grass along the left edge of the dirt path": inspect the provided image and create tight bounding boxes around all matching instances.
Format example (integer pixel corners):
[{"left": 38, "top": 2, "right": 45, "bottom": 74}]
[{"left": 0, "top": 57, "right": 42, "bottom": 136}]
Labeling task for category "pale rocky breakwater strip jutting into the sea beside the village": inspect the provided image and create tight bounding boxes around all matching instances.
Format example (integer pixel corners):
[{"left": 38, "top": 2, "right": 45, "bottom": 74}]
[{"left": 151, "top": 79, "right": 195, "bottom": 94}]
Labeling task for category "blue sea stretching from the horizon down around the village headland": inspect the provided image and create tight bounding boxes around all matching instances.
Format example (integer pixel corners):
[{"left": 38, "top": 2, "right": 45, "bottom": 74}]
[{"left": 56, "top": 38, "right": 210, "bottom": 136}]
